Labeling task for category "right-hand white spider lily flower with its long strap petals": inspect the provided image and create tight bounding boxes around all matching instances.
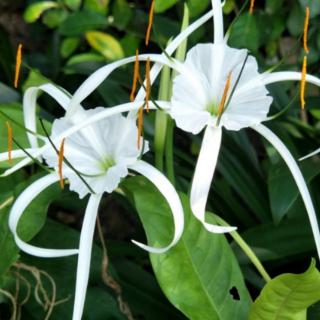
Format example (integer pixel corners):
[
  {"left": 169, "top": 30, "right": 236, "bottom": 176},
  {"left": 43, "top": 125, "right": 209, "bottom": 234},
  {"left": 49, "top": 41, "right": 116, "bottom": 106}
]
[{"left": 169, "top": 0, "right": 320, "bottom": 257}]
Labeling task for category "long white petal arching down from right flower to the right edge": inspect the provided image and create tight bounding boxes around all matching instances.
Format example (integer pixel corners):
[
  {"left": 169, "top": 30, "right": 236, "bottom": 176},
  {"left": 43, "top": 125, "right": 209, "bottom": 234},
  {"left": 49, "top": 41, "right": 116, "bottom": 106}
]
[{"left": 252, "top": 124, "right": 320, "bottom": 258}]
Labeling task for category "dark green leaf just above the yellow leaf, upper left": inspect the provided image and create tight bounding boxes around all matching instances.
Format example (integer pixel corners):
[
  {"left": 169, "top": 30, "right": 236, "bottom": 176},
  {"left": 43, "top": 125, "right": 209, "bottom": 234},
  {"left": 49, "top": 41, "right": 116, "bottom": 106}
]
[{"left": 58, "top": 11, "right": 108, "bottom": 37}]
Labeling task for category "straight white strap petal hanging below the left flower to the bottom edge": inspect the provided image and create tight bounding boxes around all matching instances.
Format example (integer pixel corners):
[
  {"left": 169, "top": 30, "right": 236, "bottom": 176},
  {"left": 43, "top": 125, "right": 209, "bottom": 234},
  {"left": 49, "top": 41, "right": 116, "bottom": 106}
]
[{"left": 72, "top": 194, "right": 102, "bottom": 320}]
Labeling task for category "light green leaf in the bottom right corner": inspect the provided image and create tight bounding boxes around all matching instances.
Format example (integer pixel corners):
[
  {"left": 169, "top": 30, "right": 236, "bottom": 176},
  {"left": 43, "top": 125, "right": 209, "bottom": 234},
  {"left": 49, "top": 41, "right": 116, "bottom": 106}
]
[{"left": 249, "top": 260, "right": 320, "bottom": 320}]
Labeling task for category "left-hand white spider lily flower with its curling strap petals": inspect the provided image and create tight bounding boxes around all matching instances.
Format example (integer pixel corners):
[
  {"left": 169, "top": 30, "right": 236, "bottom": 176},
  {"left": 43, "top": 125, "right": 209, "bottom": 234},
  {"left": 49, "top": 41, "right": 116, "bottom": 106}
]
[{"left": 5, "top": 84, "right": 184, "bottom": 320}]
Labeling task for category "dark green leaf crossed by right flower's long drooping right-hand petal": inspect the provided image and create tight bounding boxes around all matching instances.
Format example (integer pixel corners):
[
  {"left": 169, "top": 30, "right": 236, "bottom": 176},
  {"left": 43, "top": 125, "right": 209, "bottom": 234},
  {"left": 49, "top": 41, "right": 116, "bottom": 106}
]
[{"left": 268, "top": 161, "right": 320, "bottom": 224}]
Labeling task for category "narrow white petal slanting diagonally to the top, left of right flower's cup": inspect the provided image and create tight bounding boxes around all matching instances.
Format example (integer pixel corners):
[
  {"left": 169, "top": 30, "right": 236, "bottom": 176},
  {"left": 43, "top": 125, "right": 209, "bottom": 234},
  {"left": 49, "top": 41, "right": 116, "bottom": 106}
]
[{"left": 136, "top": 10, "right": 213, "bottom": 100}]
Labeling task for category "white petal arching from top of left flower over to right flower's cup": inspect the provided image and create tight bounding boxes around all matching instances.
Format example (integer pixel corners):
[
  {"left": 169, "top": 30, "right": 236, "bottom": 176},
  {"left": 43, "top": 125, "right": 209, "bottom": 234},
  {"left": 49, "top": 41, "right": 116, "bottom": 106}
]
[{"left": 67, "top": 54, "right": 182, "bottom": 116}]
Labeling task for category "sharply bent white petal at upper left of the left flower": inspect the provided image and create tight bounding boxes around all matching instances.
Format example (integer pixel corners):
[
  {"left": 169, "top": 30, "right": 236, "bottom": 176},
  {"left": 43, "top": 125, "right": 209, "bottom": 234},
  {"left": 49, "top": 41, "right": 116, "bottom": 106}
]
[{"left": 23, "top": 83, "right": 74, "bottom": 148}]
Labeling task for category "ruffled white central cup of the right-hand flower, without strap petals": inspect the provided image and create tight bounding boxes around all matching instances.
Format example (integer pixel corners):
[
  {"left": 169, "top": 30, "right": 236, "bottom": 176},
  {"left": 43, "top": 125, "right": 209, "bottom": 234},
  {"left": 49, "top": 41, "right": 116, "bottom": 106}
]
[{"left": 170, "top": 43, "right": 272, "bottom": 134}]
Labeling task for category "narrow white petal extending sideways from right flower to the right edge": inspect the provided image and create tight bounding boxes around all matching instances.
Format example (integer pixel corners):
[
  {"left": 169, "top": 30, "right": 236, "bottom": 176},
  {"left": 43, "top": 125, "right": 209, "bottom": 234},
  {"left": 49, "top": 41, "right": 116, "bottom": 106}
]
[{"left": 262, "top": 71, "right": 320, "bottom": 87}]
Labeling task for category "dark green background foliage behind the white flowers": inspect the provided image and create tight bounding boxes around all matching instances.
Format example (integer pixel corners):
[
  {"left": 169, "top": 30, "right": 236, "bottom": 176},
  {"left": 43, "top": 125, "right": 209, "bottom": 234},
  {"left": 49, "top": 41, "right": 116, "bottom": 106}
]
[{"left": 0, "top": 0, "right": 320, "bottom": 320}]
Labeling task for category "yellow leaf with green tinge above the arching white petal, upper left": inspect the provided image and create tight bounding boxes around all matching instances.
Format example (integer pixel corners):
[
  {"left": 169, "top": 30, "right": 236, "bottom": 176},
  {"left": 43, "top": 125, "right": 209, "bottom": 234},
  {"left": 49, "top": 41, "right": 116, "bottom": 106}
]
[{"left": 86, "top": 31, "right": 124, "bottom": 60}]
